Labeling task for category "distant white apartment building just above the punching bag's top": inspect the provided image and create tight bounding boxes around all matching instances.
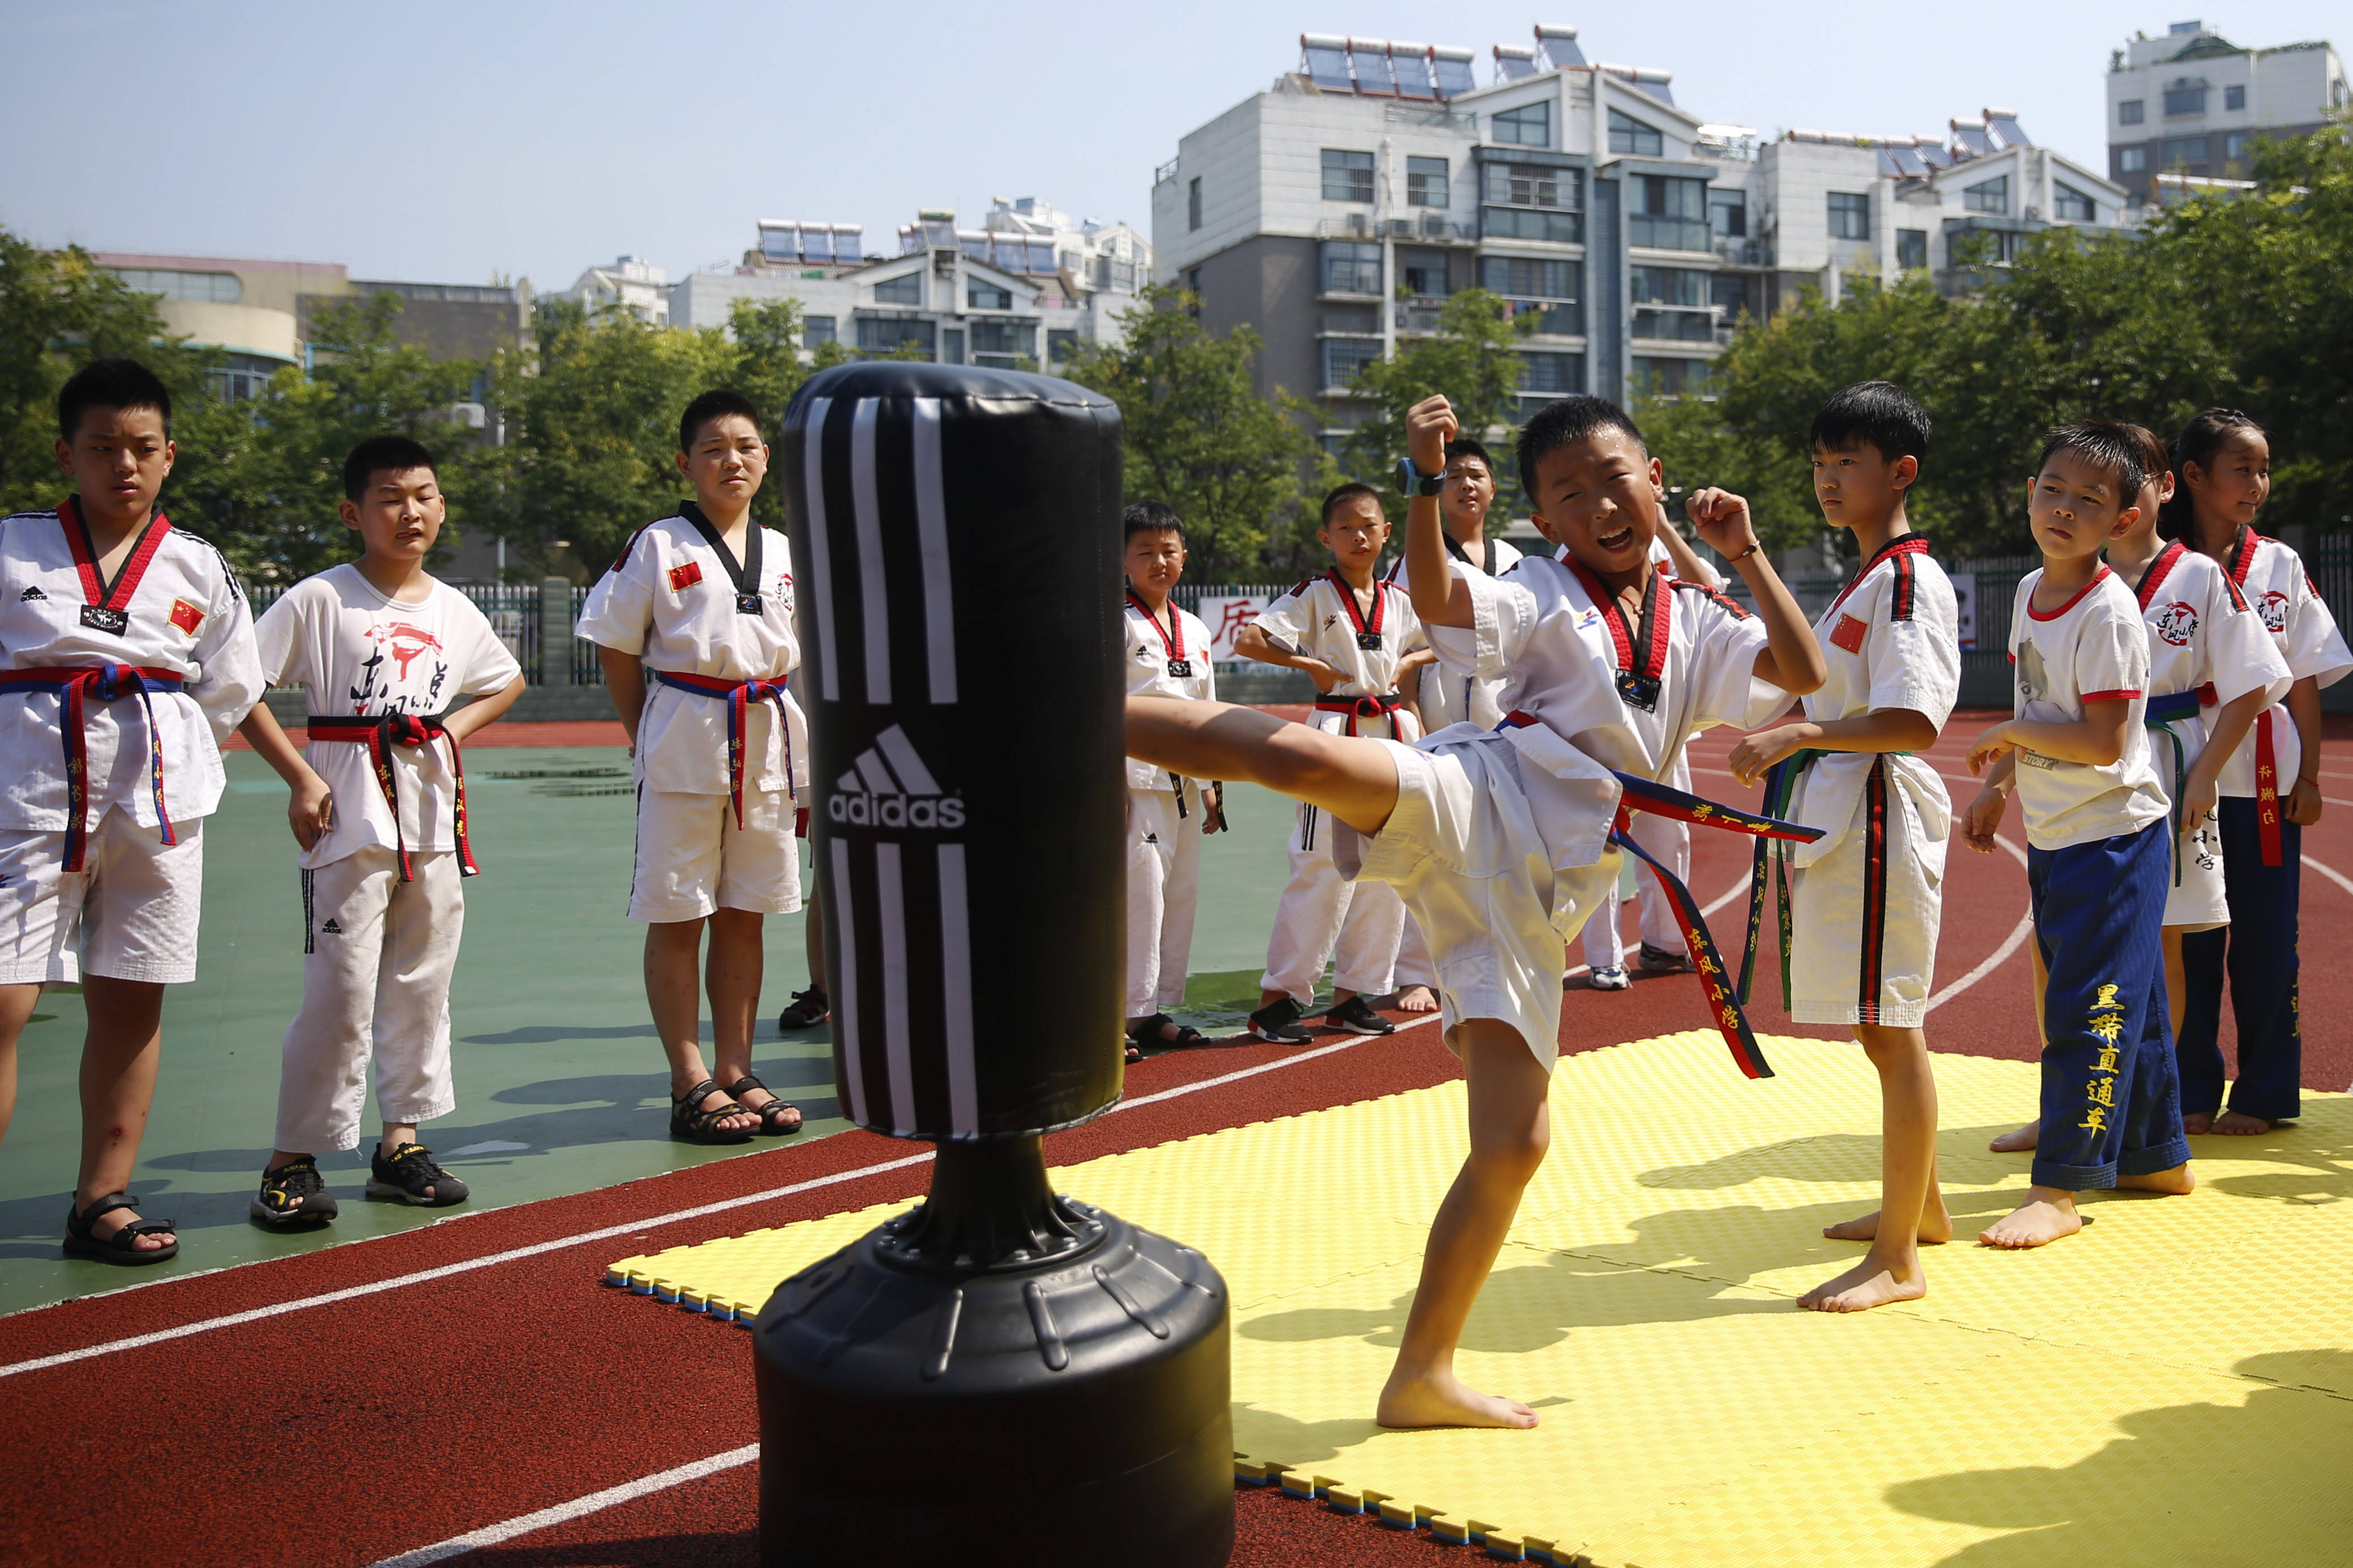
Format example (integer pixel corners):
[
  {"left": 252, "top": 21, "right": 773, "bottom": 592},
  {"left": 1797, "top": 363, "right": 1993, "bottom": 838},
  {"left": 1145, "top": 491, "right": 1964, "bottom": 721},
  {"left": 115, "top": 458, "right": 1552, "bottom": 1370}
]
[{"left": 668, "top": 198, "right": 1150, "bottom": 369}]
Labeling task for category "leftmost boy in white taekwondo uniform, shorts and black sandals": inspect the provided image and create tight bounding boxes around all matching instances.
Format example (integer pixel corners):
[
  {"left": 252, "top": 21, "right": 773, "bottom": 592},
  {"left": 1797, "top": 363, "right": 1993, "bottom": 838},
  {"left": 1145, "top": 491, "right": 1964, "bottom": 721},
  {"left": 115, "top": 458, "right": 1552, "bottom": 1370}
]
[{"left": 0, "top": 359, "right": 261, "bottom": 1265}]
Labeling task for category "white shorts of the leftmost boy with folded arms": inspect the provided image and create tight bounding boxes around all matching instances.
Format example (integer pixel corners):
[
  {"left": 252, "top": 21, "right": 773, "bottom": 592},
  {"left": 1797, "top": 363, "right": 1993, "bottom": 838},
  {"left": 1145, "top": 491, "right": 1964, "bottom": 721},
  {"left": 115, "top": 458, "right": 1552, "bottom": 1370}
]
[{"left": 0, "top": 806, "right": 205, "bottom": 985}]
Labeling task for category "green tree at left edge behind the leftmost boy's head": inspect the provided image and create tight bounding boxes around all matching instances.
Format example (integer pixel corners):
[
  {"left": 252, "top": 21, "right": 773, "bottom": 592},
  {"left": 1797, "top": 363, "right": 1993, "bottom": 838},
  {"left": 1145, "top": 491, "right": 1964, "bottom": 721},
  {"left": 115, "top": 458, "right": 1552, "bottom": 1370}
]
[{"left": 0, "top": 228, "right": 214, "bottom": 512}]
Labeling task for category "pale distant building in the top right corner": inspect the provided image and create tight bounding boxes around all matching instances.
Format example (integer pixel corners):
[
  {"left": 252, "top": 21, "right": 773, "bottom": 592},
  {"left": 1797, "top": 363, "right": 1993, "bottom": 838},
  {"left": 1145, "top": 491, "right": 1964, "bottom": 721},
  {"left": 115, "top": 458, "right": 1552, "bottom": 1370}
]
[{"left": 2108, "top": 21, "right": 2353, "bottom": 202}]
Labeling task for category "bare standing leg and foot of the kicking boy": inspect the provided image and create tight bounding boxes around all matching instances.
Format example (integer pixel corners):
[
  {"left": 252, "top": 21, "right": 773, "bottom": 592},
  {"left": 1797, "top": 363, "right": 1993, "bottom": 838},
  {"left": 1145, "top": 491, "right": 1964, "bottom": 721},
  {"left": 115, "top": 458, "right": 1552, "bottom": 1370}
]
[{"left": 1374, "top": 1020, "right": 1551, "bottom": 1427}]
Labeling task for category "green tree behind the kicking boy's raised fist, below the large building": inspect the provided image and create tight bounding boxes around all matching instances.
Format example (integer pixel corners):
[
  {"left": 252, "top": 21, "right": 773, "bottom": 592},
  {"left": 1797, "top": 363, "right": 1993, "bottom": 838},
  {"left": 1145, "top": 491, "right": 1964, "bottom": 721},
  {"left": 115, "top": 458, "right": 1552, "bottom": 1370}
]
[{"left": 1341, "top": 289, "right": 1537, "bottom": 520}]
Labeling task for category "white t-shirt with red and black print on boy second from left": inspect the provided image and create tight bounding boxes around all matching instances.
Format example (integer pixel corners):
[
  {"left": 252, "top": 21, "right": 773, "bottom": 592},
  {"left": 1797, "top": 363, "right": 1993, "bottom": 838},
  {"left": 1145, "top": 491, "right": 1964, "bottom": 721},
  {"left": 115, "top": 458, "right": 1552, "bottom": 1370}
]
[{"left": 254, "top": 564, "right": 523, "bottom": 870}]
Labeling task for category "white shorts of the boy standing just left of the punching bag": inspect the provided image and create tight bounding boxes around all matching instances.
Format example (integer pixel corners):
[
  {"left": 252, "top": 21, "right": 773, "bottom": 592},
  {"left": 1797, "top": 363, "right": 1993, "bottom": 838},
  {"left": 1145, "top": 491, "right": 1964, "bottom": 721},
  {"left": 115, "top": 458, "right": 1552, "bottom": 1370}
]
[{"left": 628, "top": 785, "right": 800, "bottom": 924}]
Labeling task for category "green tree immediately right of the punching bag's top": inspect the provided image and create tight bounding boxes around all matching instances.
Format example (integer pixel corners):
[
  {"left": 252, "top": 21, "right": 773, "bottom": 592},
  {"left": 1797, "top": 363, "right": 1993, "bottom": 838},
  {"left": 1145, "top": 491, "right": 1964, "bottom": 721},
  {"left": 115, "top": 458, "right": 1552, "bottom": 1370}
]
[{"left": 1061, "top": 287, "right": 1329, "bottom": 583}]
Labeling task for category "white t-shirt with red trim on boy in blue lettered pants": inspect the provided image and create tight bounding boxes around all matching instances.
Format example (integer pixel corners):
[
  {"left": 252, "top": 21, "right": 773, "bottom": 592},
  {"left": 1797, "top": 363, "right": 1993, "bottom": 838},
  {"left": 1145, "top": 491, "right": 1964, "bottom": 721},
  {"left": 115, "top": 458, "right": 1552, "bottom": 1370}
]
[{"left": 2009, "top": 564, "right": 2167, "bottom": 849}]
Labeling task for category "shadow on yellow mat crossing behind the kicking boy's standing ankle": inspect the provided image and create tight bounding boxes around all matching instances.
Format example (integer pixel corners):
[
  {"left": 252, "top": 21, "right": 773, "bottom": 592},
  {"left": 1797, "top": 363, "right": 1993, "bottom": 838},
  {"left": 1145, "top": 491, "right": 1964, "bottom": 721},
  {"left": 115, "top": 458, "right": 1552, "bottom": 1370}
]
[{"left": 1235, "top": 1253, "right": 1789, "bottom": 1354}]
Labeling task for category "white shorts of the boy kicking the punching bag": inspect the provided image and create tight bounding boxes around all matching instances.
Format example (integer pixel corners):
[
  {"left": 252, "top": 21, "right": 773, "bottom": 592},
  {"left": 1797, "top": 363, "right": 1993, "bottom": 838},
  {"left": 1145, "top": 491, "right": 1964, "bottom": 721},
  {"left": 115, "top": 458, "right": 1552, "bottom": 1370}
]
[{"left": 1332, "top": 740, "right": 1621, "bottom": 1067}]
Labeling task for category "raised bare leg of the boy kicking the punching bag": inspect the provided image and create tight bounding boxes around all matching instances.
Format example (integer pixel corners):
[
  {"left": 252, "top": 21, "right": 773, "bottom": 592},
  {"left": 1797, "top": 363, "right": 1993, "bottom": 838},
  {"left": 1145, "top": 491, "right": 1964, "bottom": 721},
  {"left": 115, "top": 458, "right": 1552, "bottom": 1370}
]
[{"left": 1127, "top": 696, "right": 1398, "bottom": 834}]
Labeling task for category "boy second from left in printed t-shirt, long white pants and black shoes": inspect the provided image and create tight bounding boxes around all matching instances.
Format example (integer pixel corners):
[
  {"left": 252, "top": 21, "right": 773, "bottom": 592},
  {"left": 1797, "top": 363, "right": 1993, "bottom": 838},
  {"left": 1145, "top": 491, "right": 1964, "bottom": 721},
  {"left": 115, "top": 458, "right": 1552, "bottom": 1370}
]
[{"left": 242, "top": 435, "right": 523, "bottom": 1225}]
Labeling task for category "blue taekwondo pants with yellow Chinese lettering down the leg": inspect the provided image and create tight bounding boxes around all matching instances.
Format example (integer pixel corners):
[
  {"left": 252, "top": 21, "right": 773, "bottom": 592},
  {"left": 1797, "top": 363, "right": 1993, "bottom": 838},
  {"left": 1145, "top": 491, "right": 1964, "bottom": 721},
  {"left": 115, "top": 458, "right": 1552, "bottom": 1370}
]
[{"left": 2026, "top": 818, "right": 2191, "bottom": 1192}]
